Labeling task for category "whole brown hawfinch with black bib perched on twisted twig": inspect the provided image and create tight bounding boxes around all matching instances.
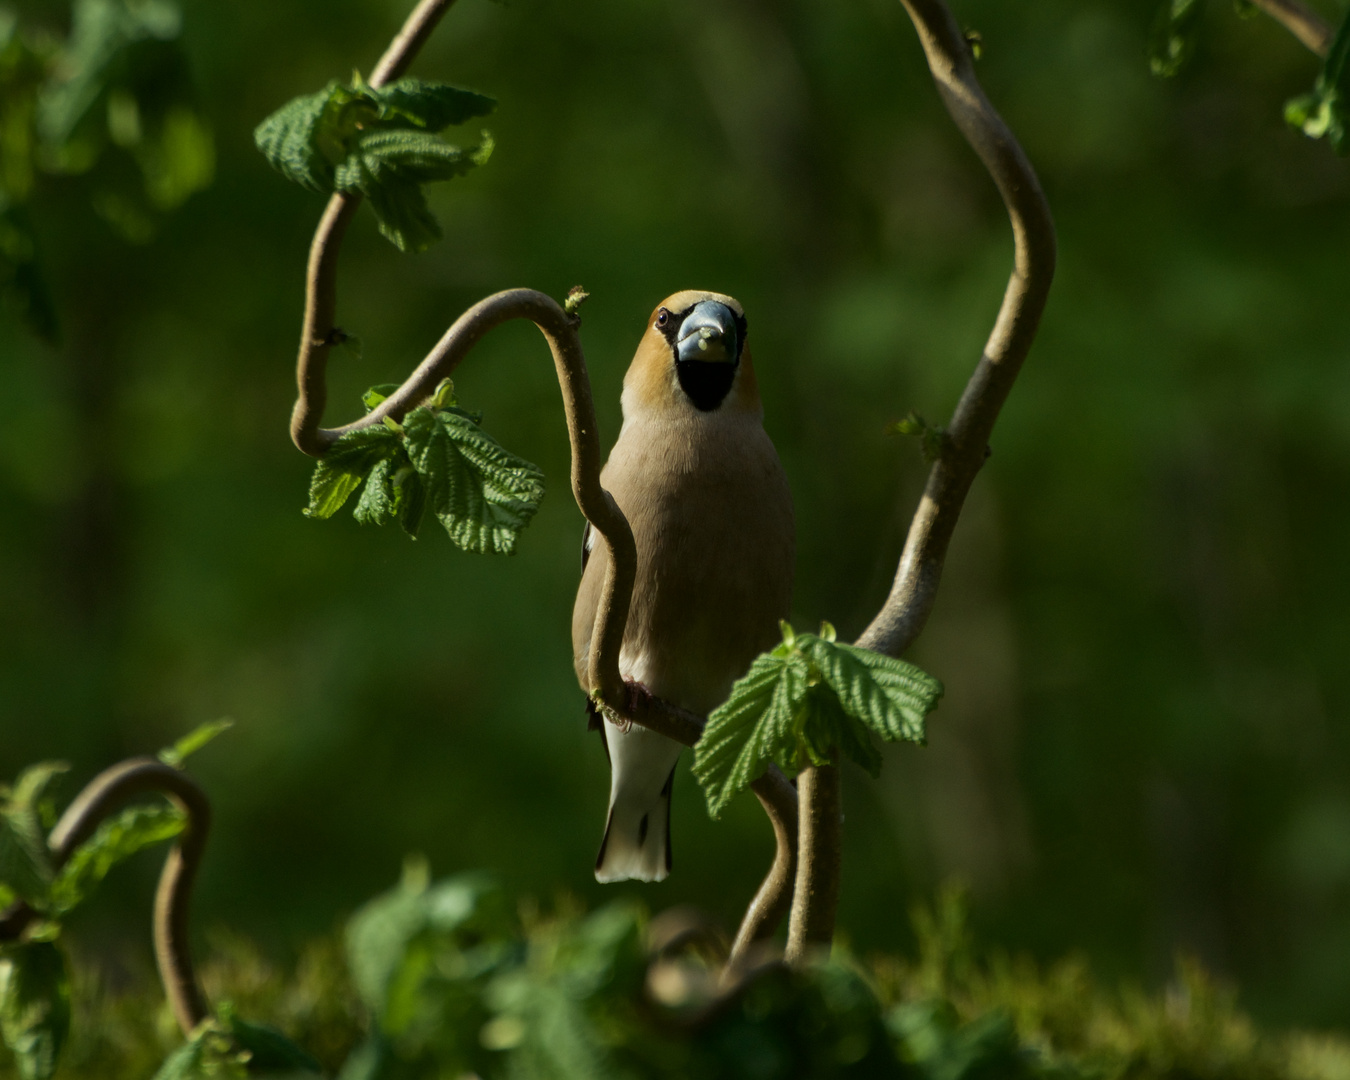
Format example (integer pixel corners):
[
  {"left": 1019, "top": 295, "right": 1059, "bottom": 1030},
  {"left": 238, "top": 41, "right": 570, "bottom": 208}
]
[{"left": 572, "top": 290, "right": 797, "bottom": 882}]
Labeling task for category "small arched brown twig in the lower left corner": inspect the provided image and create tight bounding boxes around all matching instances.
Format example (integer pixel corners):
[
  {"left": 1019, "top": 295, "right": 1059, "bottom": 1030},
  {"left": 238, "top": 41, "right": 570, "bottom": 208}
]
[{"left": 0, "top": 757, "right": 211, "bottom": 1037}]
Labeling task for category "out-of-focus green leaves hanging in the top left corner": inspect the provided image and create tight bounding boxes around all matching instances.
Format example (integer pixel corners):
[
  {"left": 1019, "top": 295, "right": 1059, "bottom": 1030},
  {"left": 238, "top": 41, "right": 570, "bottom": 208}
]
[{"left": 0, "top": 0, "right": 215, "bottom": 340}]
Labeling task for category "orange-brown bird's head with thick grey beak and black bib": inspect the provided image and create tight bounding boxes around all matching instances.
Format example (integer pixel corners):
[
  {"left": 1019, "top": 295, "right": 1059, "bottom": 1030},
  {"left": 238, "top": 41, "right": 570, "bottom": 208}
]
[{"left": 624, "top": 289, "right": 760, "bottom": 416}]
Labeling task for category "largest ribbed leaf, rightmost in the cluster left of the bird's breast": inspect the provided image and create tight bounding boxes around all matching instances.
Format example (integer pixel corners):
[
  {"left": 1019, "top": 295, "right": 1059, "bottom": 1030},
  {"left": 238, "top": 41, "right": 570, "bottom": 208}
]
[{"left": 404, "top": 406, "right": 544, "bottom": 555}]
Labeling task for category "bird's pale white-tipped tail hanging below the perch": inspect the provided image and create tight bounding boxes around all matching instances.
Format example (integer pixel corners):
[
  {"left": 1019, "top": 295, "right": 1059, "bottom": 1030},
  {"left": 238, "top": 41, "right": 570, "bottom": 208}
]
[{"left": 595, "top": 721, "right": 682, "bottom": 882}]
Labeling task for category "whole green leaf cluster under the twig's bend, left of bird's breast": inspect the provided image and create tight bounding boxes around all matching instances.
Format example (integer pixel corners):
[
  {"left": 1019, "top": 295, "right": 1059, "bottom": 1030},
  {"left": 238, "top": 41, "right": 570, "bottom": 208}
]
[{"left": 305, "top": 379, "right": 544, "bottom": 555}]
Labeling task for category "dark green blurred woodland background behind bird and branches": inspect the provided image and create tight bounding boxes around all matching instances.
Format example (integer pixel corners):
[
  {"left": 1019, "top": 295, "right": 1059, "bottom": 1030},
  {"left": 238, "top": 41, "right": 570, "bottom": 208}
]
[{"left": 0, "top": 0, "right": 1350, "bottom": 1025}]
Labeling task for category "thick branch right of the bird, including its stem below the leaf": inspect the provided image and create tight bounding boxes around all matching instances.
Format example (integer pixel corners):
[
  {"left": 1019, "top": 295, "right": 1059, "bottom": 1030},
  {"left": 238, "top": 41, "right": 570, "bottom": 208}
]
[{"left": 788, "top": 0, "right": 1056, "bottom": 963}]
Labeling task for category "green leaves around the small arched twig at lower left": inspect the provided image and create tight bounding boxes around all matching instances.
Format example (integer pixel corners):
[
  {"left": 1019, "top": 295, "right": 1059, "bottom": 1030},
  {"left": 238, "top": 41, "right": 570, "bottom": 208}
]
[{"left": 0, "top": 724, "right": 223, "bottom": 1080}]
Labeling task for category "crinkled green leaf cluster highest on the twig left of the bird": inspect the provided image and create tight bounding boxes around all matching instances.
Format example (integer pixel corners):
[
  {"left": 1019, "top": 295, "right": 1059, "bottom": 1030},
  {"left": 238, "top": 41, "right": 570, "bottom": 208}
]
[{"left": 254, "top": 76, "right": 497, "bottom": 251}]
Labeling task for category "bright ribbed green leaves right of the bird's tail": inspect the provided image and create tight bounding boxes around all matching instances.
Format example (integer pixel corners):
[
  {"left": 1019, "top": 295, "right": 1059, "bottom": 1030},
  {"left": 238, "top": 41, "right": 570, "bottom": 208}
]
[{"left": 694, "top": 622, "right": 942, "bottom": 817}]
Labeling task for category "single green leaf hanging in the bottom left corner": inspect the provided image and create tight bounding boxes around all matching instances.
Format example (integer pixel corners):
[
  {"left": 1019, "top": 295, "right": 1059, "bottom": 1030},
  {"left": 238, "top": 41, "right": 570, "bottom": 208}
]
[{"left": 0, "top": 941, "right": 70, "bottom": 1080}]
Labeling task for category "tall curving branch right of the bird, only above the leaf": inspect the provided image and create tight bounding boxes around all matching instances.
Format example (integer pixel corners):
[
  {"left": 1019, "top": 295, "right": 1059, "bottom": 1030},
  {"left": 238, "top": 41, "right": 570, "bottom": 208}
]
[{"left": 857, "top": 0, "right": 1056, "bottom": 656}]
